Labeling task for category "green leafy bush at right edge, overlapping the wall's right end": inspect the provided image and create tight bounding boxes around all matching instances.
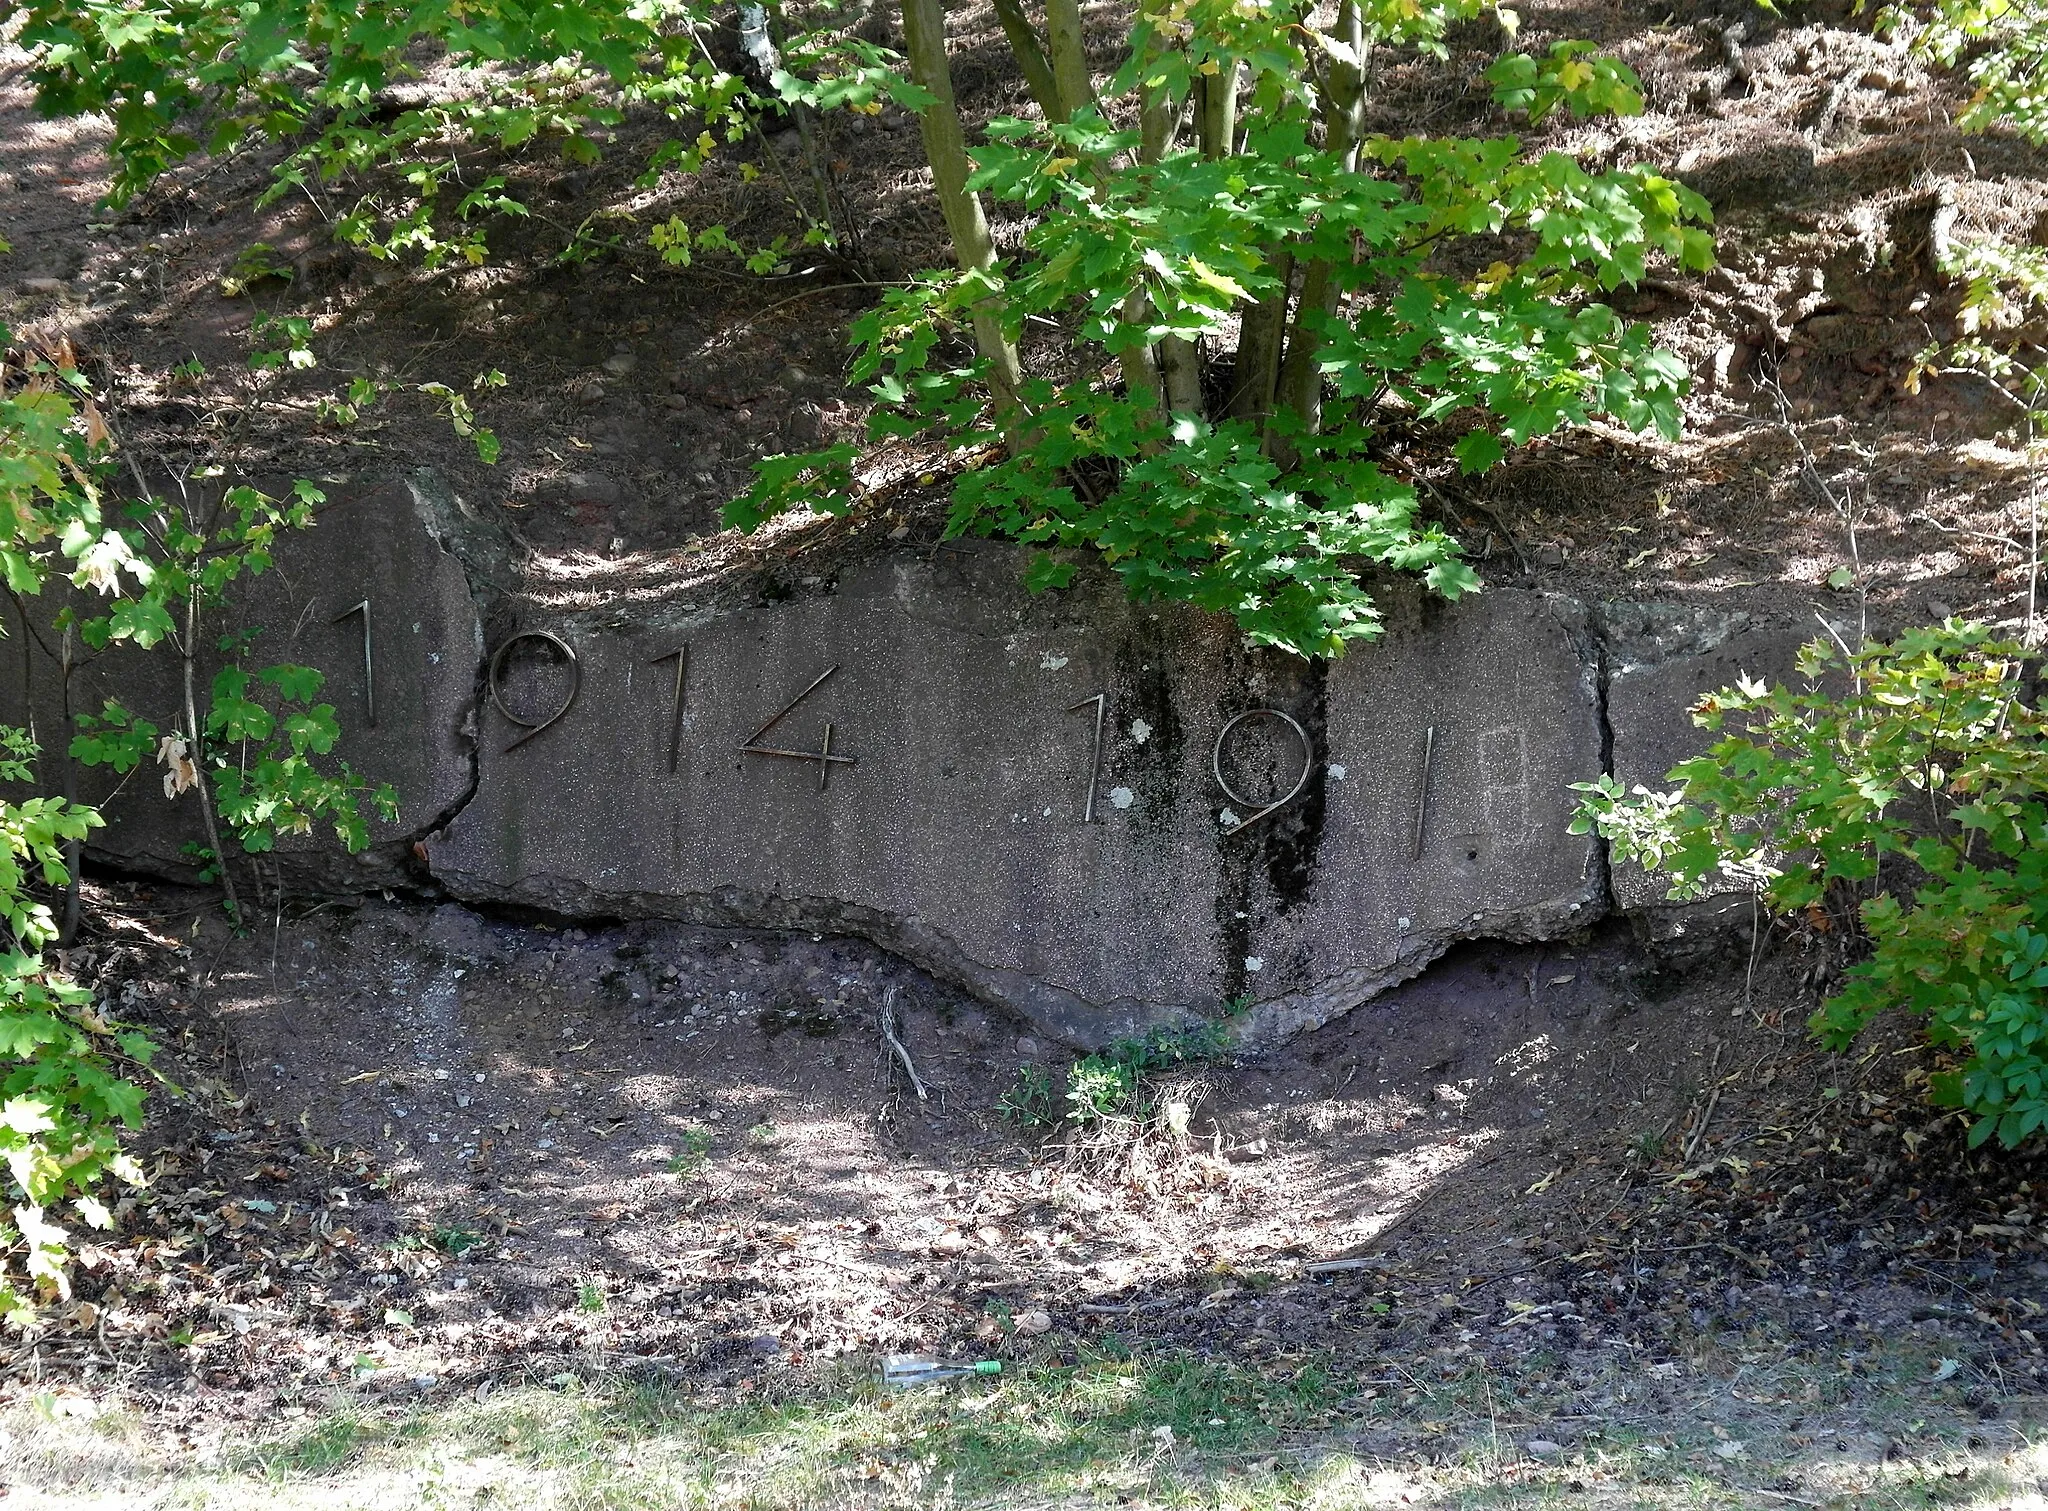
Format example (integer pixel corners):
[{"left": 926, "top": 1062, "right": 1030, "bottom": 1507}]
[{"left": 1573, "top": 620, "right": 2048, "bottom": 1147}]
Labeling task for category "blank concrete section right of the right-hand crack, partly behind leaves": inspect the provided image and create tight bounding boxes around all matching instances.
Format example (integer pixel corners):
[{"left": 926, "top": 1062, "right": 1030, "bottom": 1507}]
[{"left": 1597, "top": 602, "right": 1819, "bottom": 936}]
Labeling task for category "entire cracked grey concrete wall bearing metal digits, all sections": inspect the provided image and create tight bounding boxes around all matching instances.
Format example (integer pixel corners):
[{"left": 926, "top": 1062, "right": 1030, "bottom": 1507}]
[{"left": 4, "top": 475, "right": 1818, "bottom": 1044}]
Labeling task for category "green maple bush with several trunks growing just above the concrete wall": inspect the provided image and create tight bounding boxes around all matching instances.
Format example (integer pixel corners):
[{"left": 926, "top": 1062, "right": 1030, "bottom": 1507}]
[{"left": 727, "top": 0, "right": 1712, "bottom": 655}]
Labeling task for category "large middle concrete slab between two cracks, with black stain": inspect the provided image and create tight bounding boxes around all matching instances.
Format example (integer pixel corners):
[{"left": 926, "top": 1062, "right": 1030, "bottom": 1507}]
[{"left": 430, "top": 547, "right": 1604, "bottom": 1042}]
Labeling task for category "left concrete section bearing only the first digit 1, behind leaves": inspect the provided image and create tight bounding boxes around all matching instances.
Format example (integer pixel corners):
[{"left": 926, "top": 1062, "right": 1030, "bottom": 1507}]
[{"left": 0, "top": 483, "right": 483, "bottom": 889}]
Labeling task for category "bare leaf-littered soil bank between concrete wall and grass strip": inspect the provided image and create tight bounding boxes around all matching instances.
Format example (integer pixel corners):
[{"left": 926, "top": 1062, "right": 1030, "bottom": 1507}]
[{"left": 6, "top": 884, "right": 2048, "bottom": 1445}]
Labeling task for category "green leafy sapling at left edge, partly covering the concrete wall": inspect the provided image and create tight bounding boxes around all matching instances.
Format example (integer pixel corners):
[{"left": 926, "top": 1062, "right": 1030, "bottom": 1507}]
[{"left": 0, "top": 303, "right": 393, "bottom": 1321}]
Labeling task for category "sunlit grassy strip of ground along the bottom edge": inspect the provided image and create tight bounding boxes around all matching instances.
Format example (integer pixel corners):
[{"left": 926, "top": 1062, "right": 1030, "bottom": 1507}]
[{"left": 0, "top": 1355, "right": 2048, "bottom": 1511}]
